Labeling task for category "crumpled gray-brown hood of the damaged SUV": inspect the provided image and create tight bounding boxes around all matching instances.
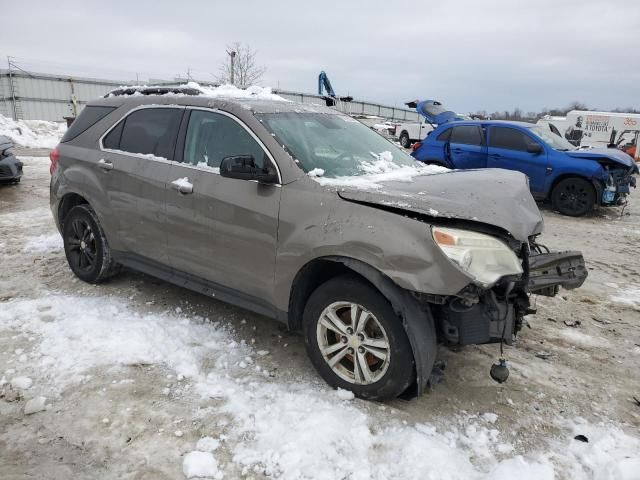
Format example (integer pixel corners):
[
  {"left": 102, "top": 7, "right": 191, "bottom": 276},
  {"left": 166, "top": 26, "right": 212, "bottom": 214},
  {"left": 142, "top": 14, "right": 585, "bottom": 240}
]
[{"left": 338, "top": 169, "right": 544, "bottom": 242}]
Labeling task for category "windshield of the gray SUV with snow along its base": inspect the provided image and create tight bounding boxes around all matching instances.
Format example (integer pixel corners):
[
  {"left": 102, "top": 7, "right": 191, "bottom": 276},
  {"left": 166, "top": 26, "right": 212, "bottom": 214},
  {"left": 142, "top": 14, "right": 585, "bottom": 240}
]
[{"left": 256, "top": 112, "right": 418, "bottom": 178}]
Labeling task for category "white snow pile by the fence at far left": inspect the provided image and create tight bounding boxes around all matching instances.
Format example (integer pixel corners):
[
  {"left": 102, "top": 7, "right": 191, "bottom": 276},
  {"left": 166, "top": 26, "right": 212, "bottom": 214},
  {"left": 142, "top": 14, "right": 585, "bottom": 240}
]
[{"left": 0, "top": 115, "right": 67, "bottom": 148}]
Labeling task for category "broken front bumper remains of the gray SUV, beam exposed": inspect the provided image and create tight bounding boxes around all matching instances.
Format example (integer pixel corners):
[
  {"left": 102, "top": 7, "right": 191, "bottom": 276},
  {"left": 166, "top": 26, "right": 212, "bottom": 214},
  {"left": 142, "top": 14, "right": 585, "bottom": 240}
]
[{"left": 435, "top": 246, "right": 588, "bottom": 345}]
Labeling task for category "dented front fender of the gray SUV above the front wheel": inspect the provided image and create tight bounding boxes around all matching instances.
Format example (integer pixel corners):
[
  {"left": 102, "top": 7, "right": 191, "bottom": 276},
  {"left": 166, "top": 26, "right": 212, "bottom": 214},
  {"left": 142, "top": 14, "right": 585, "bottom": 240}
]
[{"left": 274, "top": 179, "right": 471, "bottom": 311}]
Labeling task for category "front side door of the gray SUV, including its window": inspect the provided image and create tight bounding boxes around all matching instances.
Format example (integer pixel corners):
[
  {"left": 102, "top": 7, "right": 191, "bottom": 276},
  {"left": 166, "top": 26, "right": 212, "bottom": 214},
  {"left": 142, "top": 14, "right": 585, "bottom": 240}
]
[{"left": 167, "top": 109, "right": 282, "bottom": 307}]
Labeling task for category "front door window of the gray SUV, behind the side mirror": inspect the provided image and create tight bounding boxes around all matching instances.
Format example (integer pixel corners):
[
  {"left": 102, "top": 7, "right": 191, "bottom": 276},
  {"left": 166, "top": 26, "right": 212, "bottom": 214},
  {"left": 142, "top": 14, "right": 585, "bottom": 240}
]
[{"left": 183, "top": 110, "right": 269, "bottom": 169}]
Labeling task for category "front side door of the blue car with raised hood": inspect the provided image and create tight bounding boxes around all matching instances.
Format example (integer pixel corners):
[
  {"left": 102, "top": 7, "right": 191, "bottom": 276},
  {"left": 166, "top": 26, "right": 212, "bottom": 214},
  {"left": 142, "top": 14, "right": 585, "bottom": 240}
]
[{"left": 488, "top": 126, "right": 550, "bottom": 195}]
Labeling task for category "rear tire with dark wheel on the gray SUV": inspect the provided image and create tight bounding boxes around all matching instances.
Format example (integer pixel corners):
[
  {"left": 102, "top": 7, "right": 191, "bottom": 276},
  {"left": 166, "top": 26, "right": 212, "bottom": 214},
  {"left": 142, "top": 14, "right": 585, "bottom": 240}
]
[{"left": 62, "top": 204, "right": 120, "bottom": 283}]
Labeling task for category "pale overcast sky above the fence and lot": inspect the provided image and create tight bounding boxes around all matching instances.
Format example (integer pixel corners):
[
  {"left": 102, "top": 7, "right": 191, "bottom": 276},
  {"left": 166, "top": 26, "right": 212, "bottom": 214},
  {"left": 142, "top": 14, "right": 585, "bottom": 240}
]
[{"left": 0, "top": 0, "right": 640, "bottom": 112}]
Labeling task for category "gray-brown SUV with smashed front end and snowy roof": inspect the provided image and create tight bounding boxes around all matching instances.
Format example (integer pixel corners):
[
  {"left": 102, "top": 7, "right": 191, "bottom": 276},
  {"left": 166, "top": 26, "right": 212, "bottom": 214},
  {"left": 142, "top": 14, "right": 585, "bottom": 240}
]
[{"left": 51, "top": 88, "right": 587, "bottom": 400}]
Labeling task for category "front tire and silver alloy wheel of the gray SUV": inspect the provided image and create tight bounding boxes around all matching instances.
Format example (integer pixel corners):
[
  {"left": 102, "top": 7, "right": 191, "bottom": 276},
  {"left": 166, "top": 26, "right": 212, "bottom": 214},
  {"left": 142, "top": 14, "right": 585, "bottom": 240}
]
[{"left": 303, "top": 275, "right": 415, "bottom": 400}]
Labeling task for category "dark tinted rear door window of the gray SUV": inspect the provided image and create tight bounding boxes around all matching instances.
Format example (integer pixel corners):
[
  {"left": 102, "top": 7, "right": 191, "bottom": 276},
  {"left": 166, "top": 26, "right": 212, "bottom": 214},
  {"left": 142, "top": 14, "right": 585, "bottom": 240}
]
[{"left": 102, "top": 108, "right": 184, "bottom": 159}]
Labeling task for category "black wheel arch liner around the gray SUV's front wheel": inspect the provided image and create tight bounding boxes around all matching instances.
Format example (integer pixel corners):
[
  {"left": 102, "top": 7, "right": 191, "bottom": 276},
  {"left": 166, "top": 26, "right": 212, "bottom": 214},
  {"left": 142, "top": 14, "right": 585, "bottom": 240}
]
[{"left": 287, "top": 256, "right": 437, "bottom": 396}]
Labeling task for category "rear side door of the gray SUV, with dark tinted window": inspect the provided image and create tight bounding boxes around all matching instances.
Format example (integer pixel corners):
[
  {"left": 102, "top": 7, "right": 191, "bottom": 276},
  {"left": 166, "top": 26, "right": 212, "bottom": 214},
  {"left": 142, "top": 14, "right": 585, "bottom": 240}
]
[{"left": 98, "top": 107, "right": 184, "bottom": 265}]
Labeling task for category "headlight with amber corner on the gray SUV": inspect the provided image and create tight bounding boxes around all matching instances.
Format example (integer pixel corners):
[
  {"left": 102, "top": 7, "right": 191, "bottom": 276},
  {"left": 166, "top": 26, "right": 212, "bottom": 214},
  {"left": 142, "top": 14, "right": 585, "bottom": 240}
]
[{"left": 431, "top": 227, "right": 522, "bottom": 287}]
